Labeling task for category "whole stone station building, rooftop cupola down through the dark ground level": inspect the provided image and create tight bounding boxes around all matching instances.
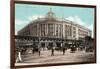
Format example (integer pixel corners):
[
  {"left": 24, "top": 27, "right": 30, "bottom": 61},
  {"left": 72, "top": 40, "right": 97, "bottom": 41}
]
[{"left": 16, "top": 9, "right": 91, "bottom": 51}]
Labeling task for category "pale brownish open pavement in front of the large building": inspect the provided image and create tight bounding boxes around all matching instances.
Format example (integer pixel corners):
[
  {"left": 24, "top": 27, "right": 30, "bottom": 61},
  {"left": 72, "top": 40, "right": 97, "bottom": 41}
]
[{"left": 16, "top": 50, "right": 94, "bottom": 65}]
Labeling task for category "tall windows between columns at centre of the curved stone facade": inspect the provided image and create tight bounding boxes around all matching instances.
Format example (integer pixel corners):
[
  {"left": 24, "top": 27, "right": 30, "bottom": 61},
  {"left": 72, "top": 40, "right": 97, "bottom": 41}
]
[{"left": 40, "top": 24, "right": 62, "bottom": 37}]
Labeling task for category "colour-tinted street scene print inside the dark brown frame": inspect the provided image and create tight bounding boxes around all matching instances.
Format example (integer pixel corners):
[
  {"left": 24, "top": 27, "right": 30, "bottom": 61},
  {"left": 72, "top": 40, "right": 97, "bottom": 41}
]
[{"left": 10, "top": 2, "right": 96, "bottom": 67}]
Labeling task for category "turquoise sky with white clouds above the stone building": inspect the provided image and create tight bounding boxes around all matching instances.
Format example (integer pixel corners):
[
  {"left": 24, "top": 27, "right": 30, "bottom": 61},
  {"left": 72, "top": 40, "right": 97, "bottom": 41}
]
[{"left": 15, "top": 4, "right": 94, "bottom": 36}]
